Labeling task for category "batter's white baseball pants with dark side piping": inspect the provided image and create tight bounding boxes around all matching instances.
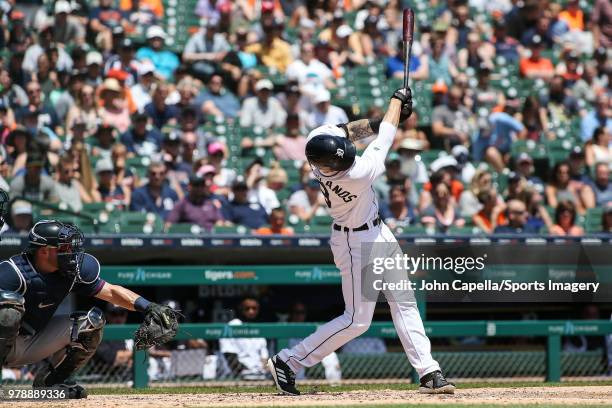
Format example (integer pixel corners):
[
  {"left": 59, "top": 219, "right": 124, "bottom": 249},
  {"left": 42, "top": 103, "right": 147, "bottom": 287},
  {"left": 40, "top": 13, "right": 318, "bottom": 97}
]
[{"left": 278, "top": 221, "right": 440, "bottom": 377}]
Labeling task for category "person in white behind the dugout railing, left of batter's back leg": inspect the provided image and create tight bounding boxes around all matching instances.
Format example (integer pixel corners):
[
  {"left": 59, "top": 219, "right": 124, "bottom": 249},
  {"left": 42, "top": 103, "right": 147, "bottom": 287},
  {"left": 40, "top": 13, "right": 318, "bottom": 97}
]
[{"left": 219, "top": 297, "right": 268, "bottom": 380}]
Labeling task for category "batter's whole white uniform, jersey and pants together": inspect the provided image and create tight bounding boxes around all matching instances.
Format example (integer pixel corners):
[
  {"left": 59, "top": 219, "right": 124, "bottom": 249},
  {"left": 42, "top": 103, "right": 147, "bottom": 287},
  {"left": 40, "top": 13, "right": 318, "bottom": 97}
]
[{"left": 278, "top": 118, "right": 440, "bottom": 377}]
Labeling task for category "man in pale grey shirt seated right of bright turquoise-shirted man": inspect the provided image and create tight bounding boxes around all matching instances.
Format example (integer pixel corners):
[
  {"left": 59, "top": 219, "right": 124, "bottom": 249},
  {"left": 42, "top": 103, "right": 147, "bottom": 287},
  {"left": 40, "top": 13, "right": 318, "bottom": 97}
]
[{"left": 183, "top": 19, "right": 231, "bottom": 78}]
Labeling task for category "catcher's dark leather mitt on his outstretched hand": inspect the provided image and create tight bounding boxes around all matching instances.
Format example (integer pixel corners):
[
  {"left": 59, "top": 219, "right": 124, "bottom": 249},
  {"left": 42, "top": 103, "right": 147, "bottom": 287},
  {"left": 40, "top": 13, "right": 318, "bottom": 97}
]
[{"left": 134, "top": 303, "right": 178, "bottom": 350}]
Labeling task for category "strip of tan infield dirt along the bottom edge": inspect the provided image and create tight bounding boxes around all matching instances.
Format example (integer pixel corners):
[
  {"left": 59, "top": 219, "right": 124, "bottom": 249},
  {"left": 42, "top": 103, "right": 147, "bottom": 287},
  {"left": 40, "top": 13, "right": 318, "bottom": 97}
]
[{"left": 11, "top": 386, "right": 612, "bottom": 408}]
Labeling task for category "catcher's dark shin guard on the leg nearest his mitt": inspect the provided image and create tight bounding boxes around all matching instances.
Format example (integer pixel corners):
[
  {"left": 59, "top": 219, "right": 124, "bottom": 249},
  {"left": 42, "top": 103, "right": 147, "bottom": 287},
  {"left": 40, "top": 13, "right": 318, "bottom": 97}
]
[{"left": 33, "top": 307, "right": 106, "bottom": 387}]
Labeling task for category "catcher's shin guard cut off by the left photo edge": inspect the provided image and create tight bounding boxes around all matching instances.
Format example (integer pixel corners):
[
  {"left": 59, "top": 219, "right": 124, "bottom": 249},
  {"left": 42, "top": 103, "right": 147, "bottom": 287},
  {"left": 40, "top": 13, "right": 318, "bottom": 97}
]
[{"left": 0, "top": 290, "right": 25, "bottom": 368}]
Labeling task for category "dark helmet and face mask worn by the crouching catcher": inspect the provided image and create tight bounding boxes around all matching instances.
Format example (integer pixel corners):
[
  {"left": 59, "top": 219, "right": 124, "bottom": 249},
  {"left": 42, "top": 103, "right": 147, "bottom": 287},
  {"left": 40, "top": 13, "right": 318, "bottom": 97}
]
[{"left": 27, "top": 220, "right": 84, "bottom": 280}]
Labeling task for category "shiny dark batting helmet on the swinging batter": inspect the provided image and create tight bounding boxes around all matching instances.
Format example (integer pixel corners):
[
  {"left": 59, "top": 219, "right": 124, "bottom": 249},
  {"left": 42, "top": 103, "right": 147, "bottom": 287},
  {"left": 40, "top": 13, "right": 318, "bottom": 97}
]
[{"left": 306, "top": 135, "right": 357, "bottom": 171}]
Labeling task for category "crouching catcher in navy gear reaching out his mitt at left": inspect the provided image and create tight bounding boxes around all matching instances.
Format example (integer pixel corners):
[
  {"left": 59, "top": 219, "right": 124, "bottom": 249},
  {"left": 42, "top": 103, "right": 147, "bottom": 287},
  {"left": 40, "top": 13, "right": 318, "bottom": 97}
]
[{"left": 0, "top": 220, "right": 178, "bottom": 399}]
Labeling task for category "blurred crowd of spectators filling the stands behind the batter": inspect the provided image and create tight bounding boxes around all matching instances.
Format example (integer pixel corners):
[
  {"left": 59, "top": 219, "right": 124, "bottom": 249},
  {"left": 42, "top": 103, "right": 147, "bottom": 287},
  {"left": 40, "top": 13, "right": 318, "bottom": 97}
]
[{"left": 0, "top": 0, "right": 612, "bottom": 236}]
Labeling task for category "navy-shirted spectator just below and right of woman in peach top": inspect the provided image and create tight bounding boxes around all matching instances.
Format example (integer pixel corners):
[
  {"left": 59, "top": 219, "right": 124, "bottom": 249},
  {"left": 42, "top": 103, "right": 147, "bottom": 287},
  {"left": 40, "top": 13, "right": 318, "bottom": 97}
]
[{"left": 120, "top": 112, "right": 163, "bottom": 157}]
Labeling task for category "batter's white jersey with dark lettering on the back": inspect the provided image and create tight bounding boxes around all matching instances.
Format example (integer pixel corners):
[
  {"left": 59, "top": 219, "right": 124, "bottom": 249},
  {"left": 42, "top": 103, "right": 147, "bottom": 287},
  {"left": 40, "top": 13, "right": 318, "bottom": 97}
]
[{"left": 307, "top": 122, "right": 397, "bottom": 228}]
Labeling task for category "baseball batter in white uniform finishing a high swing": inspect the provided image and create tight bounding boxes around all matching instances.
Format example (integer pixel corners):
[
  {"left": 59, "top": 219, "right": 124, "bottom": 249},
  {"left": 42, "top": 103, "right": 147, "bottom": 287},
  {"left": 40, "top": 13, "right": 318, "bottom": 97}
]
[{"left": 268, "top": 88, "right": 455, "bottom": 395}]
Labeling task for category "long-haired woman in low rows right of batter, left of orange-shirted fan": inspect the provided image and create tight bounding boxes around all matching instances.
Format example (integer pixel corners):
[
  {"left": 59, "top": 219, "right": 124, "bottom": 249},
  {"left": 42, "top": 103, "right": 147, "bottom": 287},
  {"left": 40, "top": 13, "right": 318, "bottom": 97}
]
[{"left": 421, "top": 183, "right": 465, "bottom": 233}]
